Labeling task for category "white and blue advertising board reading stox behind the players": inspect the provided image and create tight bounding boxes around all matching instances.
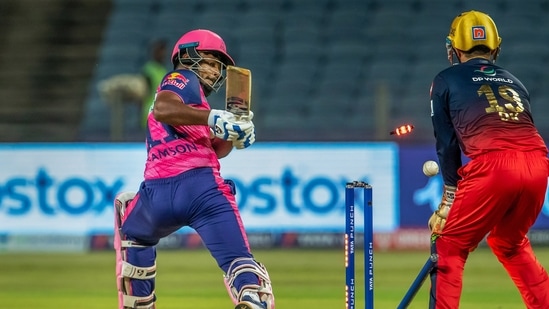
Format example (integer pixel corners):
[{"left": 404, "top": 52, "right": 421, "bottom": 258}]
[{"left": 0, "top": 143, "right": 549, "bottom": 235}]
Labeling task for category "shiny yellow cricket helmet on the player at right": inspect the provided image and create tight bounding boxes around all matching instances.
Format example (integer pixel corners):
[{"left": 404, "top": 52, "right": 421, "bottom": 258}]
[{"left": 446, "top": 11, "right": 501, "bottom": 51}]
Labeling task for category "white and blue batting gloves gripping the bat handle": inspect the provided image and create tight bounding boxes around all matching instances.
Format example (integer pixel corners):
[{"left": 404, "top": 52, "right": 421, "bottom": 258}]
[{"left": 208, "top": 109, "right": 253, "bottom": 141}]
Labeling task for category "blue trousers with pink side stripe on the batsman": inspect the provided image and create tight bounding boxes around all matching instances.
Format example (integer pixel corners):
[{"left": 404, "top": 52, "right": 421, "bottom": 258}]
[{"left": 122, "top": 168, "right": 258, "bottom": 296}]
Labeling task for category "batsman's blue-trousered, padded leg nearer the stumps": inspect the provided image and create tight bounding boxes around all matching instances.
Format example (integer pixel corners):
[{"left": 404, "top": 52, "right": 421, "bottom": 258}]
[{"left": 189, "top": 171, "right": 275, "bottom": 309}]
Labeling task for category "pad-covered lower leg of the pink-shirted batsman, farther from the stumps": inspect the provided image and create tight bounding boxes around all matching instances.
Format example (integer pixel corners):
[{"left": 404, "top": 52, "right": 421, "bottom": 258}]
[{"left": 114, "top": 192, "right": 156, "bottom": 309}]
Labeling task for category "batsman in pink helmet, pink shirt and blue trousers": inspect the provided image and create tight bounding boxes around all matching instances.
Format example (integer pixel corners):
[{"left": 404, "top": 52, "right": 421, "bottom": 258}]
[{"left": 114, "top": 29, "right": 275, "bottom": 309}]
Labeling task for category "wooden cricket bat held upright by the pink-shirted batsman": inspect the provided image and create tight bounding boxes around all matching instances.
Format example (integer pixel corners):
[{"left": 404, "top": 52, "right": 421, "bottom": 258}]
[{"left": 225, "top": 65, "right": 252, "bottom": 117}]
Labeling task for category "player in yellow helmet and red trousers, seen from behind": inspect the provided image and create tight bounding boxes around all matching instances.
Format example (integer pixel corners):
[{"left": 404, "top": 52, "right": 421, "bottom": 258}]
[{"left": 429, "top": 11, "right": 549, "bottom": 309}]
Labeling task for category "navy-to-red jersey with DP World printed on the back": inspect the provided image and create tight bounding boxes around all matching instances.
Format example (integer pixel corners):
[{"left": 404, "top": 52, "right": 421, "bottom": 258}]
[{"left": 431, "top": 58, "right": 547, "bottom": 186}]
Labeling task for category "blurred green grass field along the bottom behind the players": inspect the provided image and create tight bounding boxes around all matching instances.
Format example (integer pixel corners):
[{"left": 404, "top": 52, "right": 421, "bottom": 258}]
[{"left": 0, "top": 248, "right": 549, "bottom": 309}]
